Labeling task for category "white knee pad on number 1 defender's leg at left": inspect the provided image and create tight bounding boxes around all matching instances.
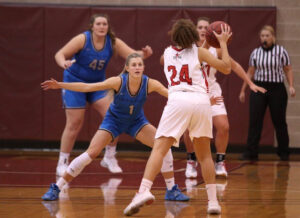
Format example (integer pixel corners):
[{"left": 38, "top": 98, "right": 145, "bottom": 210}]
[{"left": 67, "top": 152, "right": 93, "bottom": 177}]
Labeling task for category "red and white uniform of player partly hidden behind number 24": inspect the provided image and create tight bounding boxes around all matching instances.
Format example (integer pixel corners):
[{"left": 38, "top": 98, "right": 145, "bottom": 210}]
[{"left": 202, "top": 47, "right": 227, "bottom": 117}]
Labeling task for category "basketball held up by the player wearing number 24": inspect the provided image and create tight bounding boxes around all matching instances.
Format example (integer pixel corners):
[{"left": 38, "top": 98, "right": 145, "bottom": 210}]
[{"left": 205, "top": 21, "right": 232, "bottom": 48}]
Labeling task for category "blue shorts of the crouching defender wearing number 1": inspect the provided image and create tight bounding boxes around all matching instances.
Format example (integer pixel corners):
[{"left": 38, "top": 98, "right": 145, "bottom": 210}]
[{"left": 99, "top": 110, "right": 149, "bottom": 139}]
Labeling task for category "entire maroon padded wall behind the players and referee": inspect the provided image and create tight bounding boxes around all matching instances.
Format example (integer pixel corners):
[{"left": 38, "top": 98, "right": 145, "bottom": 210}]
[{"left": 0, "top": 4, "right": 276, "bottom": 145}]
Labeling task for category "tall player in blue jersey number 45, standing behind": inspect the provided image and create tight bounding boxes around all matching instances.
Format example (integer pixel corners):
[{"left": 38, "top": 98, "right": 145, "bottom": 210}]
[{"left": 55, "top": 14, "right": 152, "bottom": 176}]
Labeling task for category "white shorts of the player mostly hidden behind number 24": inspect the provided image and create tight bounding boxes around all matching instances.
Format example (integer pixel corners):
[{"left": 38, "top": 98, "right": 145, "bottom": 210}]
[{"left": 209, "top": 82, "right": 227, "bottom": 117}]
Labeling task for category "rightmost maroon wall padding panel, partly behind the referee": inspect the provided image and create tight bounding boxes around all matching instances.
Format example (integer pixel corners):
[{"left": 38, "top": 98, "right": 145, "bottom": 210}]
[{"left": 226, "top": 8, "right": 276, "bottom": 145}]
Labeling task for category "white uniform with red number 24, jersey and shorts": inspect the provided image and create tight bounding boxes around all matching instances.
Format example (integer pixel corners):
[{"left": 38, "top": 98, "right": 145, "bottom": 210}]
[{"left": 155, "top": 45, "right": 212, "bottom": 146}]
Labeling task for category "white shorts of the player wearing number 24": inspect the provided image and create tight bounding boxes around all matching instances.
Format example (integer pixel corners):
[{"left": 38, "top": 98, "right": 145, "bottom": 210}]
[{"left": 155, "top": 91, "right": 212, "bottom": 147}]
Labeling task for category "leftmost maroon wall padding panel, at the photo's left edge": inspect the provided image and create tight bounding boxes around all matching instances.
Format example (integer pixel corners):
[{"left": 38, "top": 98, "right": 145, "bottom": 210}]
[{"left": 0, "top": 6, "right": 45, "bottom": 139}]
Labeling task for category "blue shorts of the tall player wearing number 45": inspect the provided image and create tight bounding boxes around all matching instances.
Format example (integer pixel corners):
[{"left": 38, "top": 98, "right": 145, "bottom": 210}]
[{"left": 62, "top": 70, "right": 107, "bottom": 108}]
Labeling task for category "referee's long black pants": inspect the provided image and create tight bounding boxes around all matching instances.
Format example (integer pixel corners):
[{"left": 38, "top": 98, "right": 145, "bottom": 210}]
[{"left": 245, "top": 82, "right": 289, "bottom": 158}]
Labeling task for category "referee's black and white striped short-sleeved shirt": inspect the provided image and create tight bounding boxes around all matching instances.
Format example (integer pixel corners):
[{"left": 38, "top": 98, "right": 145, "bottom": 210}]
[{"left": 249, "top": 44, "right": 290, "bottom": 83}]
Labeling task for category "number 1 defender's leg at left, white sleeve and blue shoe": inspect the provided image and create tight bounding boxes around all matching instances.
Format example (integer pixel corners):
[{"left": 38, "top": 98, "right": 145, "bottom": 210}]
[{"left": 42, "top": 130, "right": 112, "bottom": 201}]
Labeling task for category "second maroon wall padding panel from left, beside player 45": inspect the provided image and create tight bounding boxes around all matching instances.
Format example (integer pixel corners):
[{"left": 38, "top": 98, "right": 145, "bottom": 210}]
[{"left": 43, "top": 7, "right": 90, "bottom": 140}]
